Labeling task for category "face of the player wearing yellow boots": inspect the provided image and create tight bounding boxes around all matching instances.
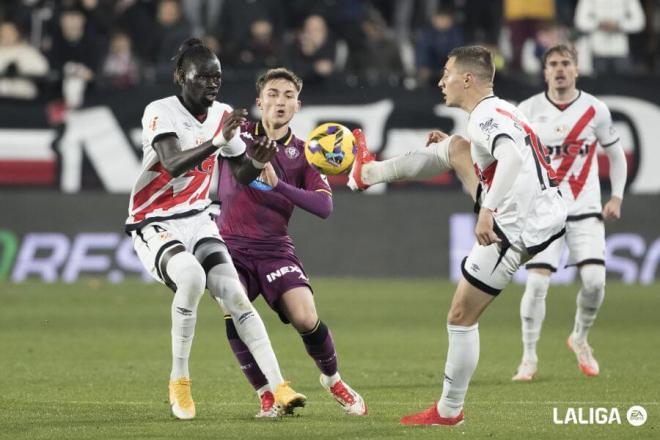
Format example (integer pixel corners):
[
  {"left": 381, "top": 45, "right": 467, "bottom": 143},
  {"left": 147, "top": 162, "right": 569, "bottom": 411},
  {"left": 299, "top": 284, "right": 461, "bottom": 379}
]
[{"left": 182, "top": 57, "right": 222, "bottom": 107}]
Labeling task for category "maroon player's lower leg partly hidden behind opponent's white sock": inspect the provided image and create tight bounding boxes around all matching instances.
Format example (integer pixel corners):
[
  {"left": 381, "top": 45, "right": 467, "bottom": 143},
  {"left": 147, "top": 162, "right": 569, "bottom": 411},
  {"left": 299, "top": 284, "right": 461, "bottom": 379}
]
[{"left": 225, "top": 314, "right": 278, "bottom": 418}]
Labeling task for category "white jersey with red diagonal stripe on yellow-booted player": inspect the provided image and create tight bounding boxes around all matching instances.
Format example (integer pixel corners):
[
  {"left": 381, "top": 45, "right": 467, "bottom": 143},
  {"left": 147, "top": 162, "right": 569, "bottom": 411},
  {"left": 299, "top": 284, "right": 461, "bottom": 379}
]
[{"left": 126, "top": 96, "right": 245, "bottom": 230}]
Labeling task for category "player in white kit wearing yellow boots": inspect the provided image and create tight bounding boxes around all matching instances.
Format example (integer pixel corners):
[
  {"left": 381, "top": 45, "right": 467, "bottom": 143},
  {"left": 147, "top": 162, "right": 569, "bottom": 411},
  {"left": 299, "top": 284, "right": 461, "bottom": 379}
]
[{"left": 126, "top": 38, "right": 305, "bottom": 419}]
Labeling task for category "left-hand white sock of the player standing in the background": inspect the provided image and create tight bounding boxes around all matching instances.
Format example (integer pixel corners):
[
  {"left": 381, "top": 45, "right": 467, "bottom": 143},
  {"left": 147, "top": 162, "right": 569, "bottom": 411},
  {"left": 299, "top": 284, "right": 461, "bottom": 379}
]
[{"left": 520, "top": 271, "right": 550, "bottom": 362}]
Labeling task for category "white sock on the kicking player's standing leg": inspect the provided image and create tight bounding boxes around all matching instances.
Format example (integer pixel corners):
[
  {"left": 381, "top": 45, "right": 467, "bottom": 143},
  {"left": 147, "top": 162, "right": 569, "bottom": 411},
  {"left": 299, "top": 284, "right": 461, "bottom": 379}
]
[{"left": 437, "top": 323, "right": 479, "bottom": 417}]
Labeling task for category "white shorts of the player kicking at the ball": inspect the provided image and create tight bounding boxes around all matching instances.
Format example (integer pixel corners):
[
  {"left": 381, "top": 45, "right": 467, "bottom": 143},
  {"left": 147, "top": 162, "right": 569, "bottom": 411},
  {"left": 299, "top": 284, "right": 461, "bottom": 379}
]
[{"left": 461, "top": 240, "right": 532, "bottom": 295}]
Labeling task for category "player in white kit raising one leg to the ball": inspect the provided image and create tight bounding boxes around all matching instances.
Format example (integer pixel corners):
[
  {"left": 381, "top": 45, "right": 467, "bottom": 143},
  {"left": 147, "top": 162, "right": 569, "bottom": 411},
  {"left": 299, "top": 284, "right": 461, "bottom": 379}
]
[{"left": 351, "top": 46, "right": 566, "bottom": 425}]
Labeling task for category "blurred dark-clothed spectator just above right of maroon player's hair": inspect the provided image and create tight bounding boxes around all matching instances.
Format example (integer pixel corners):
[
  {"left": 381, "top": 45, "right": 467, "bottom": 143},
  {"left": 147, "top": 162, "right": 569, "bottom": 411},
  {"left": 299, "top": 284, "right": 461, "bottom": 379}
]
[{"left": 287, "top": 15, "right": 337, "bottom": 84}]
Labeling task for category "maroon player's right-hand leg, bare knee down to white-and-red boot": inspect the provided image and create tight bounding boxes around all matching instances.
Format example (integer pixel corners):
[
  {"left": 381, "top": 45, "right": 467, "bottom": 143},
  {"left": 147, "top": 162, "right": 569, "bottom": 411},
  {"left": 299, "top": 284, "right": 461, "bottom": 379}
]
[{"left": 280, "top": 286, "right": 367, "bottom": 416}]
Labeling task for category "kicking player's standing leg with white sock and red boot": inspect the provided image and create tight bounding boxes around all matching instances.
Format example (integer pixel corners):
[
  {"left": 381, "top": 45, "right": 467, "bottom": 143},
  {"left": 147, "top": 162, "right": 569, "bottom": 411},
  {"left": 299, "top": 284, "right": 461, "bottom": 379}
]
[{"left": 401, "top": 278, "right": 495, "bottom": 426}]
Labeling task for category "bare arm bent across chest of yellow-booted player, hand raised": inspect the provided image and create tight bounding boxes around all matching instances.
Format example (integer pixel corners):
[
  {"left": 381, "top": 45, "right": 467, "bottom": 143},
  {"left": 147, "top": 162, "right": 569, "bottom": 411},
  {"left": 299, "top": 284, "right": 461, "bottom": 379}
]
[{"left": 153, "top": 109, "right": 247, "bottom": 177}]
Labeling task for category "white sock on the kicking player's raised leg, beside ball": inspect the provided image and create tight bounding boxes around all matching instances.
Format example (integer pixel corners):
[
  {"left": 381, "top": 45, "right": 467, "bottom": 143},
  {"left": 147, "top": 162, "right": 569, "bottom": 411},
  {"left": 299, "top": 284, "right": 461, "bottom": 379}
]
[{"left": 362, "top": 136, "right": 451, "bottom": 185}]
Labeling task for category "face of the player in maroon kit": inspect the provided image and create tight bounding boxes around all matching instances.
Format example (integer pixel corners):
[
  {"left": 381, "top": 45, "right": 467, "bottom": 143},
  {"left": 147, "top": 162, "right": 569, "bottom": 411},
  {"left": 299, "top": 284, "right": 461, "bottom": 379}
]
[{"left": 257, "top": 79, "right": 300, "bottom": 127}]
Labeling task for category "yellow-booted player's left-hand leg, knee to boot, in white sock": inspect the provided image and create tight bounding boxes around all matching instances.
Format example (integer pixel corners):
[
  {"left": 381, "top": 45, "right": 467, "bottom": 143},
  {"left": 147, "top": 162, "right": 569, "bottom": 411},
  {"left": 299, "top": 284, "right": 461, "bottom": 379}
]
[{"left": 161, "top": 251, "right": 206, "bottom": 420}]
